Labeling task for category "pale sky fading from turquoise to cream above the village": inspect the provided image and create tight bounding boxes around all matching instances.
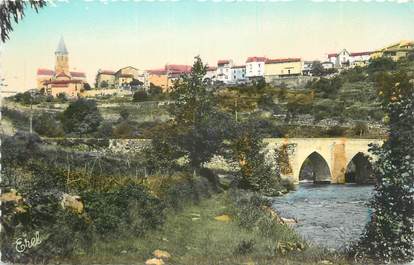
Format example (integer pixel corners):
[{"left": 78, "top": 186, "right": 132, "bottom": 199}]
[{"left": 0, "top": 0, "right": 414, "bottom": 91}]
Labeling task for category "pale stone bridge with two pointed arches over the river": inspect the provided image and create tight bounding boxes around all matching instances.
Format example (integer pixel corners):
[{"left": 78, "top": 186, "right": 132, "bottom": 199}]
[{"left": 264, "top": 138, "right": 383, "bottom": 183}]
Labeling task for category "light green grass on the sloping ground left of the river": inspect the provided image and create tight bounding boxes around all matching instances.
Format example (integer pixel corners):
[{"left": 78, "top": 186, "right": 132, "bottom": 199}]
[{"left": 68, "top": 193, "right": 360, "bottom": 265}]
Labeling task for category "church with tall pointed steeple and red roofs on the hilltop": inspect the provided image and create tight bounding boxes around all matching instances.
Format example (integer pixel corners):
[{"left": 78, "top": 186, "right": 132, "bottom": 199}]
[{"left": 37, "top": 38, "right": 86, "bottom": 98}]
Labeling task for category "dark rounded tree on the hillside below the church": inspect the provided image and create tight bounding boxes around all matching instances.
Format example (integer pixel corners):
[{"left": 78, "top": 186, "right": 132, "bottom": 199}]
[{"left": 62, "top": 98, "right": 102, "bottom": 137}]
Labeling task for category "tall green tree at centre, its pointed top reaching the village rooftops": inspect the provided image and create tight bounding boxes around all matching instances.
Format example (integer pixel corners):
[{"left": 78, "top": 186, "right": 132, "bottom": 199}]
[{"left": 169, "top": 57, "right": 230, "bottom": 170}]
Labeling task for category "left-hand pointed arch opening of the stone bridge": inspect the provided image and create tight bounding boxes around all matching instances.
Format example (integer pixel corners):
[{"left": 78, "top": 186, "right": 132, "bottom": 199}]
[{"left": 299, "top": 151, "right": 332, "bottom": 183}]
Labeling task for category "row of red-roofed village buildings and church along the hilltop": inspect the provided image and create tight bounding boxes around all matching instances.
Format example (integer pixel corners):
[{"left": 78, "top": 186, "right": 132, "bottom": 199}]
[{"left": 37, "top": 38, "right": 414, "bottom": 98}]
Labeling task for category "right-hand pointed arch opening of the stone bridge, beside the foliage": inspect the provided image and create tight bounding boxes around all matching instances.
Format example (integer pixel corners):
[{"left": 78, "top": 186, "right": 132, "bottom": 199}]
[{"left": 345, "top": 152, "right": 375, "bottom": 184}]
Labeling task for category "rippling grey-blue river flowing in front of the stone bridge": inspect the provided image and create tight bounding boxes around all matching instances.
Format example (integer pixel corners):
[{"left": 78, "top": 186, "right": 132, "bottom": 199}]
[{"left": 272, "top": 183, "right": 374, "bottom": 249}]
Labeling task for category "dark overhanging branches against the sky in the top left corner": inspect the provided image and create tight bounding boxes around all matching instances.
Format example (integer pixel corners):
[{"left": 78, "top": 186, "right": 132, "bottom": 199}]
[{"left": 0, "top": 0, "right": 46, "bottom": 42}]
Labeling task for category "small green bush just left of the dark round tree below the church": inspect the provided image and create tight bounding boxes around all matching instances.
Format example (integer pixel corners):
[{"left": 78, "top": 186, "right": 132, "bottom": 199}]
[{"left": 33, "top": 112, "right": 64, "bottom": 137}]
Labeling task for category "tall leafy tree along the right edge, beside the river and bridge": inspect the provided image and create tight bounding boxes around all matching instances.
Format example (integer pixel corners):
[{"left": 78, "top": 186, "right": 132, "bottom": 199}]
[{"left": 351, "top": 70, "right": 414, "bottom": 263}]
